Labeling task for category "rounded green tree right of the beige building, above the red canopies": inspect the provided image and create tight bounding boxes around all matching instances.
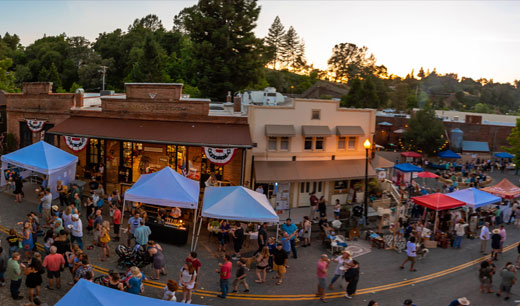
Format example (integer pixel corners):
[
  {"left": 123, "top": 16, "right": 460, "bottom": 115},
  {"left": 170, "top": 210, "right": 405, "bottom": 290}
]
[{"left": 403, "top": 105, "right": 446, "bottom": 155}]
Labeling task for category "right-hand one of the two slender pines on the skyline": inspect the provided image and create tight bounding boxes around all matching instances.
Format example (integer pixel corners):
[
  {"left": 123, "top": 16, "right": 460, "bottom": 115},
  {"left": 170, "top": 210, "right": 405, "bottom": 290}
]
[{"left": 282, "top": 26, "right": 307, "bottom": 72}]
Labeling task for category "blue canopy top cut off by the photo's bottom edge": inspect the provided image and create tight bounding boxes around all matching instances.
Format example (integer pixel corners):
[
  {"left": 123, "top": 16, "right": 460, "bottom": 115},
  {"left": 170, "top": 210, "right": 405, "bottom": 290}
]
[{"left": 55, "top": 279, "right": 207, "bottom": 306}]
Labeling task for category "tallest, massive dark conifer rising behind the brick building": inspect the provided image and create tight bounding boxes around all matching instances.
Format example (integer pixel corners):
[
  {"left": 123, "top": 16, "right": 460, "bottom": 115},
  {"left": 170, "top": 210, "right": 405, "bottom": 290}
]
[{"left": 174, "top": 0, "right": 269, "bottom": 100}]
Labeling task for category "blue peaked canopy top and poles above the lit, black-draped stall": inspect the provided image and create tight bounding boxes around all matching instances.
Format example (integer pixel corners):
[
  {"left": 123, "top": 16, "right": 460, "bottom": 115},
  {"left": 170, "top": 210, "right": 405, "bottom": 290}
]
[{"left": 123, "top": 167, "right": 200, "bottom": 250}]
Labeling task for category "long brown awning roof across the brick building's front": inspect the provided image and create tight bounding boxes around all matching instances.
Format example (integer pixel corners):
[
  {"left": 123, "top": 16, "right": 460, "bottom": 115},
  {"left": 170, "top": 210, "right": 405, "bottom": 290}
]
[{"left": 47, "top": 117, "right": 253, "bottom": 148}]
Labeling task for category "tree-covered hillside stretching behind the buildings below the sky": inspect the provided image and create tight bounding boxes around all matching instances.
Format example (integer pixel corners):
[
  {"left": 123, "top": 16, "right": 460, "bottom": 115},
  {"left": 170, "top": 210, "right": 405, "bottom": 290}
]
[{"left": 0, "top": 0, "right": 520, "bottom": 114}]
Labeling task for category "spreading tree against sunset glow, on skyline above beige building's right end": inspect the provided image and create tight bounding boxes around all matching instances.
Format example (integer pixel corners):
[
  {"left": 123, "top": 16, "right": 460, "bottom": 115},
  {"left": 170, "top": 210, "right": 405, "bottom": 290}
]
[{"left": 327, "top": 43, "right": 378, "bottom": 82}]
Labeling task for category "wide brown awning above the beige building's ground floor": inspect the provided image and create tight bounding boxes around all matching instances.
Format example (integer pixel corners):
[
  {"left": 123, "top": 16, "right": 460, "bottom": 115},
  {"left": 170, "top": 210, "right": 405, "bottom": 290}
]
[{"left": 255, "top": 159, "right": 376, "bottom": 183}]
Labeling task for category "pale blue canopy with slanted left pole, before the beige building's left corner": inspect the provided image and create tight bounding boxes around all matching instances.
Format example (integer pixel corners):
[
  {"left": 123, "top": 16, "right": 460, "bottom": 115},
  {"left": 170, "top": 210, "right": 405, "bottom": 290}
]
[{"left": 193, "top": 186, "right": 280, "bottom": 249}]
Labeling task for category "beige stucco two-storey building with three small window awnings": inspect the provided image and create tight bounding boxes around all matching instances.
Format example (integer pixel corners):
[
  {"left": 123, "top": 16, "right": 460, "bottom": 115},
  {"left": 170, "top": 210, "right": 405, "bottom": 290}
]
[{"left": 246, "top": 99, "right": 376, "bottom": 208}]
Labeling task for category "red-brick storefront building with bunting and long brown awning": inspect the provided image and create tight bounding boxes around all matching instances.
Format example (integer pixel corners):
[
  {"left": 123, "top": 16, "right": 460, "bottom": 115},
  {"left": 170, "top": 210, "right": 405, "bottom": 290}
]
[{"left": 5, "top": 83, "right": 252, "bottom": 192}]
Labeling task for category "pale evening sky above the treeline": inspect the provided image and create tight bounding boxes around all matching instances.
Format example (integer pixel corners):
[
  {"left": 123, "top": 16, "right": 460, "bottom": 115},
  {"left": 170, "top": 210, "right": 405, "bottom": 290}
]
[{"left": 0, "top": 0, "right": 520, "bottom": 82}]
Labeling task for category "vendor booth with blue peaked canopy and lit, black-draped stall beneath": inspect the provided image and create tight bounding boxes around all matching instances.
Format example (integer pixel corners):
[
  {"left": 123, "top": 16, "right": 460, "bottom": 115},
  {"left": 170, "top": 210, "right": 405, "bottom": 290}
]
[{"left": 123, "top": 167, "right": 200, "bottom": 245}]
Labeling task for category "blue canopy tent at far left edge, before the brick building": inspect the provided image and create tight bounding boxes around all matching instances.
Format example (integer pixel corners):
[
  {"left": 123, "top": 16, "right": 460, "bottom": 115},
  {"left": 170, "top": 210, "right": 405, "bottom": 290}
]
[{"left": 1, "top": 140, "right": 78, "bottom": 199}]
